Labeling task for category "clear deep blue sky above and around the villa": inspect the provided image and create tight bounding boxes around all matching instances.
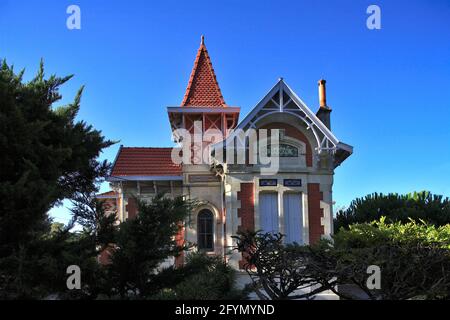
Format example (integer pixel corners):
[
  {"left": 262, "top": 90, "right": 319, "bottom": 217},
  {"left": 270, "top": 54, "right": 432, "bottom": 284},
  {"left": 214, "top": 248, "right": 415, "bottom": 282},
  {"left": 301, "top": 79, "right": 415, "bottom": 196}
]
[{"left": 0, "top": 0, "right": 450, "bottom": 225}]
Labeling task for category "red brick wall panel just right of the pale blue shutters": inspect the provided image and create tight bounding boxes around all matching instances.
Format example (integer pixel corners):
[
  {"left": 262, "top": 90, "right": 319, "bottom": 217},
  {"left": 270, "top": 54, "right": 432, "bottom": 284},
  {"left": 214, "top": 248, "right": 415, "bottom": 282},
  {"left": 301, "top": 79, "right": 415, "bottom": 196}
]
[{"left": 308, "top": 183, "right": 324, "bottom": 244}]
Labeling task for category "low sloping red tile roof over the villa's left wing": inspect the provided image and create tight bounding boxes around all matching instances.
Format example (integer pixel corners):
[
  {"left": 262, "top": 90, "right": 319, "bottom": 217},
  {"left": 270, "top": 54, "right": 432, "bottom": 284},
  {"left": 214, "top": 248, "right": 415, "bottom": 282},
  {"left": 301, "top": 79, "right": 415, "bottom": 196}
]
[{"left": 111, "top": 147, "right": 182, "bottom": 177}]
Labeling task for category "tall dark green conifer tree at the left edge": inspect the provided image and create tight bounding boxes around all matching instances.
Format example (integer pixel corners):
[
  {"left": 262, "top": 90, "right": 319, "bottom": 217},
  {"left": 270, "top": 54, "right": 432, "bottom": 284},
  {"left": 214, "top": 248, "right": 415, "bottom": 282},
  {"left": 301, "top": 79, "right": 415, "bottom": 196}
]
[{"left": 0, "top": 61, "right": 113, "bottom": 297}]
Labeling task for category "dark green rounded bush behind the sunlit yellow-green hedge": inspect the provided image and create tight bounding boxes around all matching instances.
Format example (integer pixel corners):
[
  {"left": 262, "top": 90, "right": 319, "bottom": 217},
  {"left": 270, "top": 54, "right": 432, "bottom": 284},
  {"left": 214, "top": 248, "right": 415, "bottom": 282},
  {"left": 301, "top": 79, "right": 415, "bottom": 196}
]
[{"left": 334, "top": 191, "right": 450, "bottom": 230}]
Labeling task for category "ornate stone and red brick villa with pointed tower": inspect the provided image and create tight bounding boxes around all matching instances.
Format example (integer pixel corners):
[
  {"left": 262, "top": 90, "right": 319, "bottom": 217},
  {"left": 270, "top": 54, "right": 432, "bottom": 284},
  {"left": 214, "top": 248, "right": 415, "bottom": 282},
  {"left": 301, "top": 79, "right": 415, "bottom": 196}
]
[{"left": 99, "top": 37, "right": 353, "bottom": 269}]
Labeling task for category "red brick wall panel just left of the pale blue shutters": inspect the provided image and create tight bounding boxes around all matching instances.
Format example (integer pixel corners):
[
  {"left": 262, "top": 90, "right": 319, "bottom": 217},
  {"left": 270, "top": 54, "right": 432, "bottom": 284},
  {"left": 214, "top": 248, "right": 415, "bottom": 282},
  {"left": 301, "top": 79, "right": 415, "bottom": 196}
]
[{"left": 237, "top": 182, "right": 255, "bottom": 269}]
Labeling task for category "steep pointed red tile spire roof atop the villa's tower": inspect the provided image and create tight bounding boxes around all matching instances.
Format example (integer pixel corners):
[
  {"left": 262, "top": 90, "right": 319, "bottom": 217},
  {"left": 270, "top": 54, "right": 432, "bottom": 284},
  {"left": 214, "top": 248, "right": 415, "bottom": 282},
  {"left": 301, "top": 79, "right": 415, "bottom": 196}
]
[{"left": 181, "top": 36, "right": 226, "bottom": 107}]
